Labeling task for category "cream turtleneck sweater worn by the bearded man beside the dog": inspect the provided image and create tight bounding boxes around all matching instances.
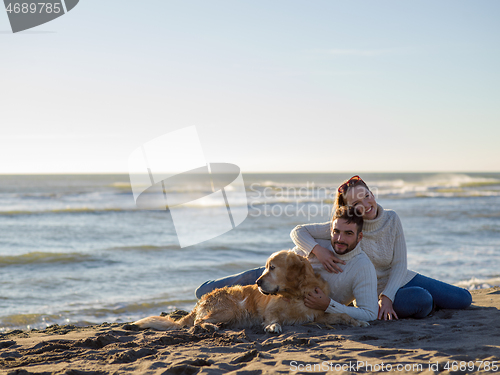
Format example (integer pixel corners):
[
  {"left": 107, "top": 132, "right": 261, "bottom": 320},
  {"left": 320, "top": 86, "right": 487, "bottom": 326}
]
[{"left": 293, "top": 239, "right": 378, "bottom": 321}]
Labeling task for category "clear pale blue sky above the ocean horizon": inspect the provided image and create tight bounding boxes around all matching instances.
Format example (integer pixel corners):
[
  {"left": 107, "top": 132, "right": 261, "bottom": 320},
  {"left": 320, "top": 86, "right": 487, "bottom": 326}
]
[{"left": 0, "top": 0, "right": 500, "bottom": 173}]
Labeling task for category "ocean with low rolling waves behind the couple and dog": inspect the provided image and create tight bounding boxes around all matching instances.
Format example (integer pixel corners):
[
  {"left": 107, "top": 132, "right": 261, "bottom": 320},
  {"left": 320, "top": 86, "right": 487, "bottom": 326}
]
[{"left": 0, "top": 173, "right": 500, "bottom": 332}]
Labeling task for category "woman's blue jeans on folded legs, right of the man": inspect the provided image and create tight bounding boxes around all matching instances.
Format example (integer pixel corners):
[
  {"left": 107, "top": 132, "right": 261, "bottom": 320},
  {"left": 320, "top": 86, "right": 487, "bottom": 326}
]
[{"left": 392, "top": 274, "right": 472, "bottom": 319}]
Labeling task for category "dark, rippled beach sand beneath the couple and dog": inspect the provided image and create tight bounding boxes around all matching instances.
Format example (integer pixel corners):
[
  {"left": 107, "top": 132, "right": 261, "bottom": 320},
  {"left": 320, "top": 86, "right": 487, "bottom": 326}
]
[{"left": 0, "top": 287, "right": 500, "bottom": 374}]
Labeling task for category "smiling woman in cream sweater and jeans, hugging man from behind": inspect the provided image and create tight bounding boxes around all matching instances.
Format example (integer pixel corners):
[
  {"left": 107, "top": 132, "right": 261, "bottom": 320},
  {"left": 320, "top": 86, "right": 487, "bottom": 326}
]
[{"left": 291, "top": 176, "right": 472, "bottom": 320}]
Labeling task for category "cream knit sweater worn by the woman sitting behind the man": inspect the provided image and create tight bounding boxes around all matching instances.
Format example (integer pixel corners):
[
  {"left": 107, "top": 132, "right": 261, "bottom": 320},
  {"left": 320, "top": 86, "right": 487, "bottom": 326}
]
[{"left": 290, "top": 205, "right": 417, "bottom": 301}]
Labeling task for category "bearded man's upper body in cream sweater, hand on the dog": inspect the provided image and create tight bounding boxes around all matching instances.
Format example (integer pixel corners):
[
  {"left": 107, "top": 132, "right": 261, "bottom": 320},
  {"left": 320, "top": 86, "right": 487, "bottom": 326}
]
[{"left": 293, "top": 207, "right": 378, "bottom": 321}]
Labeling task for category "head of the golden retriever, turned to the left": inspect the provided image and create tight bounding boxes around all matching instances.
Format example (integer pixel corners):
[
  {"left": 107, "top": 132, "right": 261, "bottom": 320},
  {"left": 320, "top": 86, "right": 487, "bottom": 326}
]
[{"left": 257, "top": 250, "right": 314, "bottom": 295}]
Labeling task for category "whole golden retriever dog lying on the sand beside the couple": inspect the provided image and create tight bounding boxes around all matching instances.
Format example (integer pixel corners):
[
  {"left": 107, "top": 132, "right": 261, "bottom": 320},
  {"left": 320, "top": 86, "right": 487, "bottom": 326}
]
[{"left": 133, "top": 250, "right": 368, "bottom": 333}]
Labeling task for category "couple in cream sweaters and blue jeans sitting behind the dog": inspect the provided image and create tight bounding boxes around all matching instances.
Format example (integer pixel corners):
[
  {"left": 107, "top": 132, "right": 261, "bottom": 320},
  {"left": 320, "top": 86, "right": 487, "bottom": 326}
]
[{"left": 196, "top": 176, "right": 472, "bottom": 320}]
